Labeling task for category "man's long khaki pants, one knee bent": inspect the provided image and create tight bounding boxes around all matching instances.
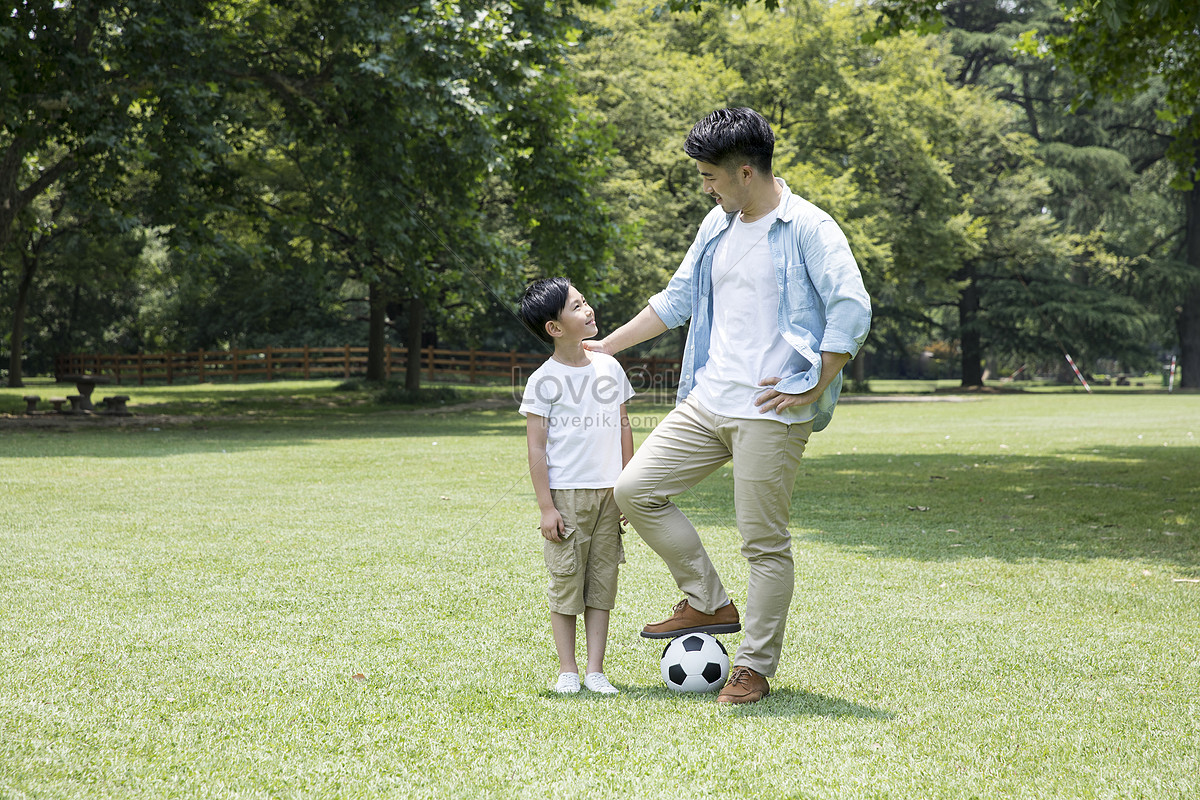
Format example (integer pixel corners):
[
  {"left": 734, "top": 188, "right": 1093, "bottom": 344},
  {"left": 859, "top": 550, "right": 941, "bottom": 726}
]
[{"left": 613, "top": 398, "right": 812, "bottom": 676}]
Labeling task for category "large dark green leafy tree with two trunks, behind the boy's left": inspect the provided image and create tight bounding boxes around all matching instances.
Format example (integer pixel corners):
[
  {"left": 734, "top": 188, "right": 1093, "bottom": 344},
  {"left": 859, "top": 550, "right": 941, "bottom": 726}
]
[{"left": 204, "top": 0, "right": 613, "bottom": 389}]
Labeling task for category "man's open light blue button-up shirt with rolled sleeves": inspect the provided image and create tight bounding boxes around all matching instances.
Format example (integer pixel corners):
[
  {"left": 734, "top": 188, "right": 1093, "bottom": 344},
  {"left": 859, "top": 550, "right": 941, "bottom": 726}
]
[{"left": 650, "top": 178, "right": 871, "bottom": 431}]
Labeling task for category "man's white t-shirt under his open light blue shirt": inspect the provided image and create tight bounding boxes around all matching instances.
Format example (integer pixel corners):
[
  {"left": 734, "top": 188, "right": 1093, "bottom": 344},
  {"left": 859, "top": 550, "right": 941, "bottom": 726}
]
[{"left": 691, "top": 211, "right": 816, "bottom": 423}]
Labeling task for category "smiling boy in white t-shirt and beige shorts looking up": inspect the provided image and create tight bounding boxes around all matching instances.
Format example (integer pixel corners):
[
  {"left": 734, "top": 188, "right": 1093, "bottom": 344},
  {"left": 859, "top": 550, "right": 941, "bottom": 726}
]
[{"left": 520, "top": 278, "right": 634, "bottom": 694}]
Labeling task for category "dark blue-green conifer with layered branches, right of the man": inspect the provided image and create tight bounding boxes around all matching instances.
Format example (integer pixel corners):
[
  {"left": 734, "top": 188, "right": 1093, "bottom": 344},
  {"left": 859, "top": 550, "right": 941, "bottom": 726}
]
[{"left": 926, "top": 0, "right": 1162, "bottom": 380}]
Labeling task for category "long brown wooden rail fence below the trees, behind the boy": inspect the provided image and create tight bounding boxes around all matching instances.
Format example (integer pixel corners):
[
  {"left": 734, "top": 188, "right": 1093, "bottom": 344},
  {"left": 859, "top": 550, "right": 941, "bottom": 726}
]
[{"left": 54, "top": 345, "right": 679, "bottom": 387}]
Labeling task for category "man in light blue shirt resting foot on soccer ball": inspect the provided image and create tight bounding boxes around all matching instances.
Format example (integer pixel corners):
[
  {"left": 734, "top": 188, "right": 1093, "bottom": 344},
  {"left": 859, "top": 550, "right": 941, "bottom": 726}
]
[{"left": 589, "top": 108, "right": 871, "bottom": 703}]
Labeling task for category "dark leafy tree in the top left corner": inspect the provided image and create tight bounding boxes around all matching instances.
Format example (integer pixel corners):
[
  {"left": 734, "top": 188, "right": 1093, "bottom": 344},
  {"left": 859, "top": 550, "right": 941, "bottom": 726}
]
[{"left": 0, "top": 0, "right": 234, "bottom": 386}]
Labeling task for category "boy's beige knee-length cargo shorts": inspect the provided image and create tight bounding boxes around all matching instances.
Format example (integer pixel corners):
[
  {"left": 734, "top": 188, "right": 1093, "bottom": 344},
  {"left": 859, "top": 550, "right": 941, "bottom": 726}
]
[{"left": 544, "top": 489, "right": 625, "bottom": 616}]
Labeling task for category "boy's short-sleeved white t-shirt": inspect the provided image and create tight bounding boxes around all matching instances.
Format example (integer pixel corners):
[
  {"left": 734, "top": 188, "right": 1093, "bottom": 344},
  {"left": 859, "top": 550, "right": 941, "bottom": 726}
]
[{"left": 520, "top": 353, "right": 634, "bottom": 489}]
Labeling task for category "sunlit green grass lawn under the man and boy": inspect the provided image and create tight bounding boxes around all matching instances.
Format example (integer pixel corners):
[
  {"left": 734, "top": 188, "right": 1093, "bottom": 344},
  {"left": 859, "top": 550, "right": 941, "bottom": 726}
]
[{"left": 0, "top": 381, "right": 1200, "bottom": 799}]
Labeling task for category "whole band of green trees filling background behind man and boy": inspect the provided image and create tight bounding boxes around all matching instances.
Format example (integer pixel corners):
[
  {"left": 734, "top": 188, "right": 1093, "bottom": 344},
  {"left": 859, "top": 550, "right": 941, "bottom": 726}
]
[{"left": 0, "top": 0, "right": 1200, "bottom": 385}]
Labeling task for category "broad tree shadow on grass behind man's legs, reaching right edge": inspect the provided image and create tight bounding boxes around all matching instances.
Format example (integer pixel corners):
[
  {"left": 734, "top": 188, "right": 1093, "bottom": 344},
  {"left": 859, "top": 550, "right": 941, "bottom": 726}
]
[{"left": 679, "top": 446, "right": 1200, "bottom": 575}]
